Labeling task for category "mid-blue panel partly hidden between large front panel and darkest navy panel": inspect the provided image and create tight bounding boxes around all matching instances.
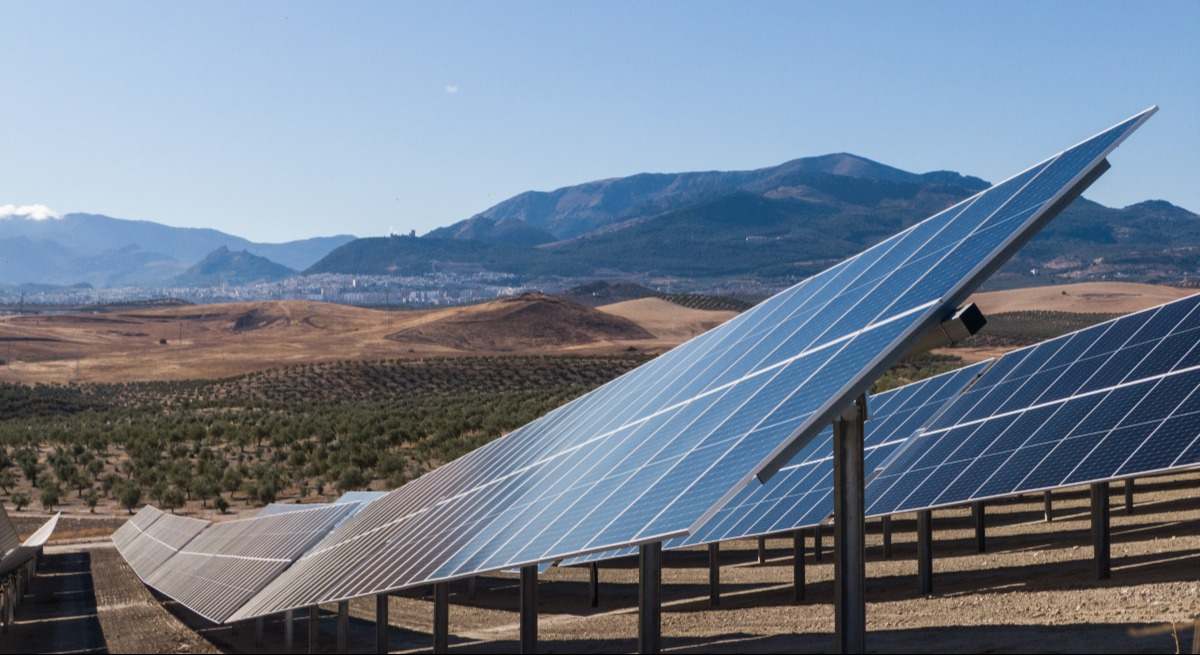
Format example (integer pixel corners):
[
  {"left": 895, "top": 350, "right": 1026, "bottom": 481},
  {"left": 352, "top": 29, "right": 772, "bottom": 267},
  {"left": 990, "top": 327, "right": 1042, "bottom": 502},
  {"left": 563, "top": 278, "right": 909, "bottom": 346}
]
[{"left": 560, "top": 360, "right": 991, "bottom": 566}]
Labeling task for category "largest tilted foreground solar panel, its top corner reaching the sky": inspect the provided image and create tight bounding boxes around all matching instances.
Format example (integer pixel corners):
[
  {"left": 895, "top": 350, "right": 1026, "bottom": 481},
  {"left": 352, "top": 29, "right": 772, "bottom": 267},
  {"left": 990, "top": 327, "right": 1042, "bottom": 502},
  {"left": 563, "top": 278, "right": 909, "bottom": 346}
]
[{"left": 235, "top": 109, "right": 1154, "bottom": 619}]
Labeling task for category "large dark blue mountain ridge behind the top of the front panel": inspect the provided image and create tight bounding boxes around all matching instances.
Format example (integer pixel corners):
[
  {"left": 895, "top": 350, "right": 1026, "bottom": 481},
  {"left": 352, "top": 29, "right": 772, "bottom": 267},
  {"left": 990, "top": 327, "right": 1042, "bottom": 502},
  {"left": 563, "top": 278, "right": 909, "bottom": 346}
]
[{"left": 307, "top": 154, "right": 1200, "bottom": 287}]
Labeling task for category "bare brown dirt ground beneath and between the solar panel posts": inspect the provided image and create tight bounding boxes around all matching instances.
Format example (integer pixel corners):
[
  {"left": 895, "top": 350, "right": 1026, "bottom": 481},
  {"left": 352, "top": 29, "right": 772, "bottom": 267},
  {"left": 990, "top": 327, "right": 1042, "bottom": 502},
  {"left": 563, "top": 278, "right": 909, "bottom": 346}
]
[{"left": 11, "top": 473, "right": 1200, "bottom": 653}]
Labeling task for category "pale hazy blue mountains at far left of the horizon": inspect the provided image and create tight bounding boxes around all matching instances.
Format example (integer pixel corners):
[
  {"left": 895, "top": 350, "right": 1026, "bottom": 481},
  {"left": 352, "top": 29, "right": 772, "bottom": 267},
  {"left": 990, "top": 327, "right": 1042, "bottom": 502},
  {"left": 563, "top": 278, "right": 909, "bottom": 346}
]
[{"left": 0, "top": 214, "right": 354, "bottom": 287}]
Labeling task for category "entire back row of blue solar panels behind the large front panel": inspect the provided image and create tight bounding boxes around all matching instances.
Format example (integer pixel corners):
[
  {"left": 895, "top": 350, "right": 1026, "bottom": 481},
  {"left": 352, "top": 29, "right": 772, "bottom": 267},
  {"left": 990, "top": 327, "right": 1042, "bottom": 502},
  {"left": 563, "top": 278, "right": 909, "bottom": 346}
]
[{"left": 562, "top": 290, "right": 1200, "bottom": 565}]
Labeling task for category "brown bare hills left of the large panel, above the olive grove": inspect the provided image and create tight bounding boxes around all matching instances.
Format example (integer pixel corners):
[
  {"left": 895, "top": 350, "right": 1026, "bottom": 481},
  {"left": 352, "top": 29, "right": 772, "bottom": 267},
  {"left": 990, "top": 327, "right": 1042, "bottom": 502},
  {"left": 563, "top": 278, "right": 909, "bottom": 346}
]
[{"left": 0, "top": 294, "right": 733, "bottom": 384}]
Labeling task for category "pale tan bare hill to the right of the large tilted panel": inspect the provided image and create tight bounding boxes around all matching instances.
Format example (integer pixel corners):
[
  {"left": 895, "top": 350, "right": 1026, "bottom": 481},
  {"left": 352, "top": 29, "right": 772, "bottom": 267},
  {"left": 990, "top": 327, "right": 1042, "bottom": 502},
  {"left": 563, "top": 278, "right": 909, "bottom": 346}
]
[{"left": 971, "top": 282, "right": 1196, "bottom": 314}]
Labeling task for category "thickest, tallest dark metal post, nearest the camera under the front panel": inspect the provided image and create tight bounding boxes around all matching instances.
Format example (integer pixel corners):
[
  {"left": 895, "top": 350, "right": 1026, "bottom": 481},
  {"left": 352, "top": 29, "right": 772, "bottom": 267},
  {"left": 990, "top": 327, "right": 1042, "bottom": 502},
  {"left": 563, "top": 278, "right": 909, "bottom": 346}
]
[{"left": 833, "top": 395, "right": 866, "bottom": 653}]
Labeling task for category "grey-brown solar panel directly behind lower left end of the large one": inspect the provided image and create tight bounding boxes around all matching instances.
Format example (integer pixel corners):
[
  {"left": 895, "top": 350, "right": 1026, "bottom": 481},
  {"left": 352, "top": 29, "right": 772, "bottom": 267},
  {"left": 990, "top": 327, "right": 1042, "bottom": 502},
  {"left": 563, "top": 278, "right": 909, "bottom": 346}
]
[{"left": 146, "top": 503, "right": 359, "bottom": 623}]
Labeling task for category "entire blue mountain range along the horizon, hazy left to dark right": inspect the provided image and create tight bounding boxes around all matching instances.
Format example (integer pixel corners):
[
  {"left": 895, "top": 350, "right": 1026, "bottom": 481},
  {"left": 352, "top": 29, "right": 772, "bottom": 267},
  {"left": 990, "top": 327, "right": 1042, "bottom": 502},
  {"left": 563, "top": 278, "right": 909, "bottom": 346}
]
[{"left": 9, "top": 154, "right": 1200, "bottom": 288}]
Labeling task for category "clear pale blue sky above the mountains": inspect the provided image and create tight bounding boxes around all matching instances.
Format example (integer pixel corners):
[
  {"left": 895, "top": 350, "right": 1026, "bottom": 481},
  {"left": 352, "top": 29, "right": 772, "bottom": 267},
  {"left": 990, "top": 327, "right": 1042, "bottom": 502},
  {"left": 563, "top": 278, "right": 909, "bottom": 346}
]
[{"left": 0, "top": 0, "right": 1200, "bottom": 241}]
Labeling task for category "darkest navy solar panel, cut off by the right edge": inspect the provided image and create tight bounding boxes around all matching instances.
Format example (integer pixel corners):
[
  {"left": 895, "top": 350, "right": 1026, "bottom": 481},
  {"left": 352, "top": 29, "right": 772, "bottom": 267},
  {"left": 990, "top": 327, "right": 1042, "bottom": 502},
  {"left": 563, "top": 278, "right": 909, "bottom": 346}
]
[{"left": 868, "top": 291, "right": 1200, "bottom": 515}]
